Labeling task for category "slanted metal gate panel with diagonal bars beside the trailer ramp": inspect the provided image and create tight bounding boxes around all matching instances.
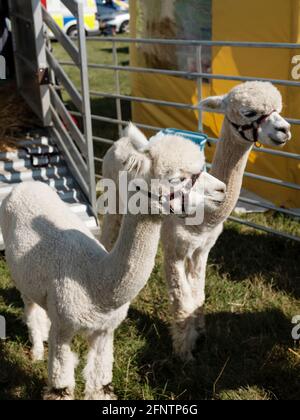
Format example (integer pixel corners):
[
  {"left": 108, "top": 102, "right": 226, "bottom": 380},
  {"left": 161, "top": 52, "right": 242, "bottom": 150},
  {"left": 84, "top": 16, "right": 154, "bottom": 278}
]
[{"left": 39, "top": 0, "right": 96, "bottom": 211}]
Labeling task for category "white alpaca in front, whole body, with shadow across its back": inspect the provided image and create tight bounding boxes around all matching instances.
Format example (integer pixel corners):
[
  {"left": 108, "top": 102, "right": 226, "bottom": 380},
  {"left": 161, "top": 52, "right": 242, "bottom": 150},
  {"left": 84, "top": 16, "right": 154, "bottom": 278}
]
[{"left": 0, "top": 126, "right": 224, "bottom": 399}]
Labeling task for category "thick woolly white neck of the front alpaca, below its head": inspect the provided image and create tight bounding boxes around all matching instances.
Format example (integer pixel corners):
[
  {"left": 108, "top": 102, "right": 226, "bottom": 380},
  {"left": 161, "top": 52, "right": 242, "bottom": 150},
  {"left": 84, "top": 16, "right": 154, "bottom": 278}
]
[{"left": 100, "top": 215, "right": 161, "bottom": 309}]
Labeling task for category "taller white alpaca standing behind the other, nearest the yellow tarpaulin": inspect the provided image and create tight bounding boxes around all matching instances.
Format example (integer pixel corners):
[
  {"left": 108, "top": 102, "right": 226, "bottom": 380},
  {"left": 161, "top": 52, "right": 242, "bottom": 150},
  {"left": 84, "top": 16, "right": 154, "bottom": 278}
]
[{"left": 102, "top": 82, "right": 291, "bottom": 360}]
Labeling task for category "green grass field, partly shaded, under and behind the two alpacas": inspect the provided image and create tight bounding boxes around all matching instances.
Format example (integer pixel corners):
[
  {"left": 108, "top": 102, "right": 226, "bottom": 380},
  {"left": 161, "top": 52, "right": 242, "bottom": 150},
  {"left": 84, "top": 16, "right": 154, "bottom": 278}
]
[{"left": 0, "top": 38, "right": 300, "bottom": 400}]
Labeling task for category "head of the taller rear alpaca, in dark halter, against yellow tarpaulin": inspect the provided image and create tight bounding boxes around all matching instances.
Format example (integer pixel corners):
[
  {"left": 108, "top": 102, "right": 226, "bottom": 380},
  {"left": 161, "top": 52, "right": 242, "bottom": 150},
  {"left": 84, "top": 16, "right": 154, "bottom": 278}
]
[{"left": 200, "top": 82, "right": 291, "bottom": 146}]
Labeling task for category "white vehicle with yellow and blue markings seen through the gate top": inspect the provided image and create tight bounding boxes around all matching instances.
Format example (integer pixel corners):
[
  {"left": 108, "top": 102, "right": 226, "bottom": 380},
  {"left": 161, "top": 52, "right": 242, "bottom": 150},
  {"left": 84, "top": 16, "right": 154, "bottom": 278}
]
[{"left": 43, "top": 0, "right": 99, "bottom": 36}]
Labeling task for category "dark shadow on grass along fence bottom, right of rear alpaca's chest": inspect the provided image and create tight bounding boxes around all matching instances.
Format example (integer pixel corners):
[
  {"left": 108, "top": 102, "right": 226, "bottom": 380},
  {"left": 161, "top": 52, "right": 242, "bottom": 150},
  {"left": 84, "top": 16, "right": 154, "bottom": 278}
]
[{"left": 210, "top": 228, "right": 300, "bottom": 299}]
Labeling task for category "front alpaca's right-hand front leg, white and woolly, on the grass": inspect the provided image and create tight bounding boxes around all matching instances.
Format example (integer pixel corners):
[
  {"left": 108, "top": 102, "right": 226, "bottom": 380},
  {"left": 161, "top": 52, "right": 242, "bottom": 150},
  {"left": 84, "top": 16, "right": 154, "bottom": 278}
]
[{"left": 84, "top": 331, "right": 117, "bottom": 400}]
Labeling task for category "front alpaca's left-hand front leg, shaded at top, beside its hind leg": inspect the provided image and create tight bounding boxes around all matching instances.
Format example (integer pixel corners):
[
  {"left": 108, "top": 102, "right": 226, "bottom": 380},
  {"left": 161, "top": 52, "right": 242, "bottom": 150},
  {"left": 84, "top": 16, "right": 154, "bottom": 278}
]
[{"left": 44, "top": 325, "right": 77, "bottom": 400}]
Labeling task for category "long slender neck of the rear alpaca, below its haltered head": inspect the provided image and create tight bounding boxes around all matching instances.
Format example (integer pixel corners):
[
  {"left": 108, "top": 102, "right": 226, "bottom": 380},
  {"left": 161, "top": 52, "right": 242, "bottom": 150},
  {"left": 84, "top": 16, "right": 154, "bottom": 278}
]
[{"left": 208, "top": 119, "right": 253, "bottom": 226}]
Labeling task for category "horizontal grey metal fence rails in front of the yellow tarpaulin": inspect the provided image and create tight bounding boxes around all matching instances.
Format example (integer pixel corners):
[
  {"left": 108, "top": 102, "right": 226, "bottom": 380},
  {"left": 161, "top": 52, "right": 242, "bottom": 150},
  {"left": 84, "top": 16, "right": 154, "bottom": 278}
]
[{"left": 56, "top": 37, "right": 300, "bottom": 241}]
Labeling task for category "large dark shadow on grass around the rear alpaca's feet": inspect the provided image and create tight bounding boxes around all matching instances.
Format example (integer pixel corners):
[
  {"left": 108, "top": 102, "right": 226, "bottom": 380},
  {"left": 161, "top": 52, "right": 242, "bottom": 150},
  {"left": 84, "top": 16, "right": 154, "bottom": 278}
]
[{"left": 129, "top": 309, "right": 300, "bottom": 400}]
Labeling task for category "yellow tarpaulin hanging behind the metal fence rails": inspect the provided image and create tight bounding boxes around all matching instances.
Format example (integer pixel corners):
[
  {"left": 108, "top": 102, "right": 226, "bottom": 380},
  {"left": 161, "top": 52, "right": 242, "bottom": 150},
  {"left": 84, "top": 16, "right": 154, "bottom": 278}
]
[{"left": 131, "top": 0, "right": 300, "bottom": 208}]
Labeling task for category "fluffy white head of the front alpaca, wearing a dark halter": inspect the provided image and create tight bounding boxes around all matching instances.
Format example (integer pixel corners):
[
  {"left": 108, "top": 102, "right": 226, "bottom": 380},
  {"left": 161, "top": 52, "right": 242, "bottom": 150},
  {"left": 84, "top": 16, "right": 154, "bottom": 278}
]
[{"left": 123, "top": 124, "right": 226, "bottom": 216}]
